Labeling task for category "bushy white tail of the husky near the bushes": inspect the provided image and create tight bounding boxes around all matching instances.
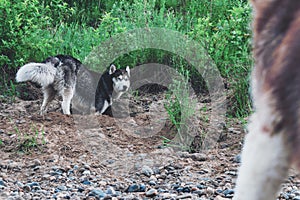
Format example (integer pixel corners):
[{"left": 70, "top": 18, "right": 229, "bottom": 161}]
[{"left": 16, "top": 63, "right": 56, "bottom": 87}]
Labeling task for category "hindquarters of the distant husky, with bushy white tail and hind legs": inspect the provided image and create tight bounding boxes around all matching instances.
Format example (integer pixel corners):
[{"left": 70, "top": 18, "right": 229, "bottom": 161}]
[{"left": 16, "top": 55, "right": 82, "bottom": 114}]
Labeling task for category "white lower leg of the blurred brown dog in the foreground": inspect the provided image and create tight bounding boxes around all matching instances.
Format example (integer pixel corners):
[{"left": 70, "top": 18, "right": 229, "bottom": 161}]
[{"left": 233, "top": 112, "right": 289, "bottom": 200}]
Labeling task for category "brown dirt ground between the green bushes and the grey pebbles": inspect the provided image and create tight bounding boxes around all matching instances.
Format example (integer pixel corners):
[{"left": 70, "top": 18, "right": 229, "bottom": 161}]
[{"left": 0, "top": 84, "right": 299, "bottom": 198}]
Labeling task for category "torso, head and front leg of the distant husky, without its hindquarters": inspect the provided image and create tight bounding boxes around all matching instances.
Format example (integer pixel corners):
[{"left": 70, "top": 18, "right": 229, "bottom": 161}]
[{"left": 72, "top": 65, "right": 130, "bottom": 116}]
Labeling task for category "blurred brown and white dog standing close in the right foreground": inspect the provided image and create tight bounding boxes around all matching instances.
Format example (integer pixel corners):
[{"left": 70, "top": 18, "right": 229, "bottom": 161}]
[{"left": 233, "top": 0, "right": 300, "bottom": 200}]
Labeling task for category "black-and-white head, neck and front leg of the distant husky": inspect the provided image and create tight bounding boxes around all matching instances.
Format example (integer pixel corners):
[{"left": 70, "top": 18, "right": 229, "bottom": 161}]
[{"left": 95, "top": 65, "right": 130, "bottom": 116}]
